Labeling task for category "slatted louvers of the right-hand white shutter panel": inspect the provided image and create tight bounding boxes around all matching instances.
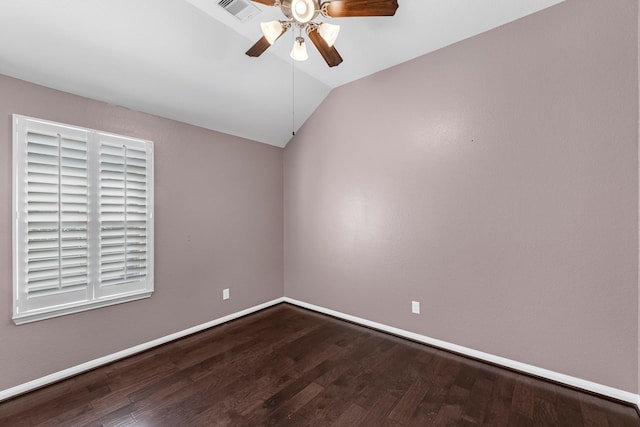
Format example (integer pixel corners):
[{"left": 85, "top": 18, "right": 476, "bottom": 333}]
[{"left": 100, "top": 143, "right": 148, "bottom": 286}]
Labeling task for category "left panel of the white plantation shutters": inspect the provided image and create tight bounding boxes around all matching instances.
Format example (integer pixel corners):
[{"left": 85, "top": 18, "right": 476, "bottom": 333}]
[{"left": 15, "top": 119, "right": 90, "bottom": 312}]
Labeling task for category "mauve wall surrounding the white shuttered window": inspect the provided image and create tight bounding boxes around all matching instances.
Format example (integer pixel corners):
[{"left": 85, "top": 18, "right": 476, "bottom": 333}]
[{"left": 0, "top": 76, "right": 284, "bottom": 390}]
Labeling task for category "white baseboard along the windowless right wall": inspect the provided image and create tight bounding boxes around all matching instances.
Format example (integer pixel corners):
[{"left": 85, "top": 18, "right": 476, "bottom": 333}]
[{"left": 284, "top": 297, "right": 640, "bottom": 408}]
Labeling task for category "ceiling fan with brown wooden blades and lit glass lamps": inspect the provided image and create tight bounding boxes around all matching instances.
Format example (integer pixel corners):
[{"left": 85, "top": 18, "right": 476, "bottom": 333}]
[{"left": 246, "top": 0, "right": 398, "bottom": 67}]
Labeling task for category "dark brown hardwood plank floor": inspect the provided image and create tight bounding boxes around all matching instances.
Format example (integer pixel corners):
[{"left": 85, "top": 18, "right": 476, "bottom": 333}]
[{"left": 0, "top": 304, "right": 640, "bottom": 427}]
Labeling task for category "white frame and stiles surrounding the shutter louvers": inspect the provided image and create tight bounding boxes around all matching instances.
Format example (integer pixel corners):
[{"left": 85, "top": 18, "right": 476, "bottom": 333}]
[{"left": 12, "top": 114, "right": 154, "bottom": 325}]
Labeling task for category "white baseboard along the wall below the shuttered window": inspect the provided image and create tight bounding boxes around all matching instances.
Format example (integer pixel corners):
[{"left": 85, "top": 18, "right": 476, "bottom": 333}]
[{"left": 0, "top": 298, "right": 284, "bottom": 402}]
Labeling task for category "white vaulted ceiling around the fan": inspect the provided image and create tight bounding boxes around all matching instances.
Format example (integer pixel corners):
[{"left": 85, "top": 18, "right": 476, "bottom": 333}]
[{"left": 0, "top": 0, "right": 564, "bottom": 147}]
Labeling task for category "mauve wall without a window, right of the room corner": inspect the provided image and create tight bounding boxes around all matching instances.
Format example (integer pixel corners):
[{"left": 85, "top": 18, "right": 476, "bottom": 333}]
[{"left": 285, "top": 0, "right": 638, "bottom": 392}]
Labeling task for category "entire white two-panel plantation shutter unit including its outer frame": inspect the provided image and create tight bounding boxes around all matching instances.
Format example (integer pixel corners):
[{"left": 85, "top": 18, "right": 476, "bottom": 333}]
[{"left": 13, "top": 115, "right": 154, "bottom": 324}]
